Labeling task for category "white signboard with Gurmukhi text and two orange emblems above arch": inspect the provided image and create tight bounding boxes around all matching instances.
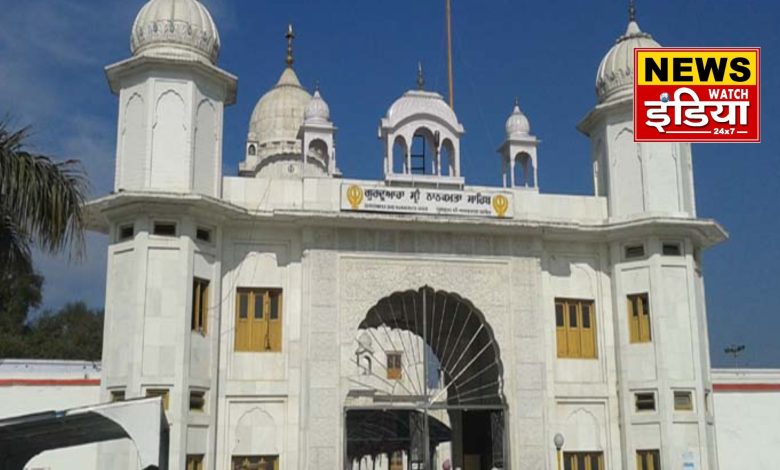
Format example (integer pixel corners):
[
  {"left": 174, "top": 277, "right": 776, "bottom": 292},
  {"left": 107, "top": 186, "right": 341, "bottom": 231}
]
[{"left": 341, "top": 183, "right": 512, "bottom": 219}]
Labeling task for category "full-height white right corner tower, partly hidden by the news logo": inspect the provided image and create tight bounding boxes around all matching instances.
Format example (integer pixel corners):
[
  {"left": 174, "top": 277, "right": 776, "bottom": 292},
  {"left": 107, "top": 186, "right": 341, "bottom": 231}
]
[{"left": 579, "top": 1, "right": 723, "bottom": 470}]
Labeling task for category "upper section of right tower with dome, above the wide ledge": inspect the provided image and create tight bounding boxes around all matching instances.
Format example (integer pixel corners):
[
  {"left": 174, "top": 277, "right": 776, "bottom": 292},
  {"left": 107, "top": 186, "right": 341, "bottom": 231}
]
[{"left": 579, "top": 3, "right": 696, "bottom": 219}]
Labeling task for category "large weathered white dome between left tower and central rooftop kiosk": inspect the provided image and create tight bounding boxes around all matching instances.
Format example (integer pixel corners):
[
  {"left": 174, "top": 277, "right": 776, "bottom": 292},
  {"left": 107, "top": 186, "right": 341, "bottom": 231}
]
[{"left": 249, "top": 67, "right": 312, "bottom": 158}]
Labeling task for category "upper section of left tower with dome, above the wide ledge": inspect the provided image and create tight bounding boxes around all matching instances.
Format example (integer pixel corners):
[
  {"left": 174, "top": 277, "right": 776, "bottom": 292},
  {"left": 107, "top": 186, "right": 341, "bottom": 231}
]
[{"left": 106, "top": 0, "right": 236, "bottom": 197}]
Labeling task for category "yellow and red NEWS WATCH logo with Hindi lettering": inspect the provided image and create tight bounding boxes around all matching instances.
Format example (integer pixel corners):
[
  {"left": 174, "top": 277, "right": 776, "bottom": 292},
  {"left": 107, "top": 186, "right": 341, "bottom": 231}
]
[{"left": 634, "top": 48, "right": 761, "bottom": 142}]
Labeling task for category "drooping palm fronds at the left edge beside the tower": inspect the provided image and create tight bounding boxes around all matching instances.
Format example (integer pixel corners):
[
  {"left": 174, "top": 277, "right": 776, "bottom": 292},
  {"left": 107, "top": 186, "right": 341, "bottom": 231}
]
[{"left": 0, "top": 120, "right": 87, "bottom": 276}]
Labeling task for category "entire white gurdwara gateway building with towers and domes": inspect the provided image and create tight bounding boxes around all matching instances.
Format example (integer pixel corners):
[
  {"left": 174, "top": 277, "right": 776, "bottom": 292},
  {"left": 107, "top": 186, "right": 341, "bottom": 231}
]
[{"left": 85, "top": 0, "right": 726, "bottom": 470}]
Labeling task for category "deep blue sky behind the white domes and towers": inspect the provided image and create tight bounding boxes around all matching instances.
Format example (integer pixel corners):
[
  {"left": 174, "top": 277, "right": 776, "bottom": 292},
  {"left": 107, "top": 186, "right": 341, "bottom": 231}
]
[{"left": 0, "top": 0, "right": 780, "bottom": 367}]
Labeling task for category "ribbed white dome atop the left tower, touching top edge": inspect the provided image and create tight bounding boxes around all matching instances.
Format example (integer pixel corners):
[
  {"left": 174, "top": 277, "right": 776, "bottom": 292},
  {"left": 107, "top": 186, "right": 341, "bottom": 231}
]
[{"left": 130, "top": 0, "right": 220, "bottom": 64}]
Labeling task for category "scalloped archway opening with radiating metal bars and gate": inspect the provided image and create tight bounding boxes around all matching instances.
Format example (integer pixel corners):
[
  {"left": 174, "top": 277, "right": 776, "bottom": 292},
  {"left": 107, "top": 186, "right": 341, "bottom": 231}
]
[{"left": 345, "top": 286, "right": 506, "bottom": 470}]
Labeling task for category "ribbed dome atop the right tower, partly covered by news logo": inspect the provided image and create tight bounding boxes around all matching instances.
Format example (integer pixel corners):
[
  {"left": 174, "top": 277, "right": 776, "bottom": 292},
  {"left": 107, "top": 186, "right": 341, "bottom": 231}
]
[{"left": 596, "top": 21, "right": 661, "bottom": 103}]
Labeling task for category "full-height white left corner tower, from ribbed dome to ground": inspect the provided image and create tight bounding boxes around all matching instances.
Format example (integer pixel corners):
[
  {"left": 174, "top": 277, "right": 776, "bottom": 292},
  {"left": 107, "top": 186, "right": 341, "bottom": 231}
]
[{"left": 98, "top": 0, "right": 237, "bottom": 470}]
